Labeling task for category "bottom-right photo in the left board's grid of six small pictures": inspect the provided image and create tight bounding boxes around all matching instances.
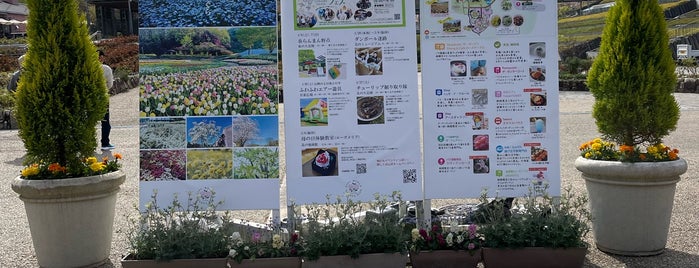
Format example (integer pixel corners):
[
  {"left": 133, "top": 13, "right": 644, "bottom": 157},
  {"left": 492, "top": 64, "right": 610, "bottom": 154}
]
[{"left": 233, "top": 147, "right": 279, "bottom": 179}]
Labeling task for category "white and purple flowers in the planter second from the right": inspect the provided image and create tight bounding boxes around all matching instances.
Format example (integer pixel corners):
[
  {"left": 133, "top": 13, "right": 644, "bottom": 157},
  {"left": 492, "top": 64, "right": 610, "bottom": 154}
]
[{"left": 408, "top": 222, "right": 482, "bottom": 254}]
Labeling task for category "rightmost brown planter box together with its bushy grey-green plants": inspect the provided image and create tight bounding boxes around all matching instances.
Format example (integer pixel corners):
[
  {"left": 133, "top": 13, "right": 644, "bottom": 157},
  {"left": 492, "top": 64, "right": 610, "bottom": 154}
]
[{"left": 478, "top": 184, "right": 591, "bottom": 268}]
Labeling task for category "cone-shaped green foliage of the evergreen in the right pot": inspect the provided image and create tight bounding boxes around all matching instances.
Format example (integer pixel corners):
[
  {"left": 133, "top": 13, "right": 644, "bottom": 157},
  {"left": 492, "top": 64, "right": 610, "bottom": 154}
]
[{"left": 587, "top": 0, "right": 680, "bottom": 146}]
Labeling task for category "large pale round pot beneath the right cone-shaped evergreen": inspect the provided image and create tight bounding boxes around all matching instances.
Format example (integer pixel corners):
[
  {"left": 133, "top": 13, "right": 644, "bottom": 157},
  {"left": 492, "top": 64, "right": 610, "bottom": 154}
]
[{"left": 575, "top": 157, "right": 687, "bottom": 256}]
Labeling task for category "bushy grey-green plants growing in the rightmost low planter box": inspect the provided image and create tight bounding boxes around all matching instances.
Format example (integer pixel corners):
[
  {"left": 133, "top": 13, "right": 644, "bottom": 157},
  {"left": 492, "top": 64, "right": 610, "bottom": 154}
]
[{"left": 479, "top": 185, "right": 591, "bottom": 248}]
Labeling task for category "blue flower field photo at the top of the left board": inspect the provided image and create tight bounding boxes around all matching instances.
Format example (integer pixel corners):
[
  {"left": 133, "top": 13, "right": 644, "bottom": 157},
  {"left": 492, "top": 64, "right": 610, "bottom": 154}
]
[{"left": 138, "top": 0, "right": 277, "bottom": 27}]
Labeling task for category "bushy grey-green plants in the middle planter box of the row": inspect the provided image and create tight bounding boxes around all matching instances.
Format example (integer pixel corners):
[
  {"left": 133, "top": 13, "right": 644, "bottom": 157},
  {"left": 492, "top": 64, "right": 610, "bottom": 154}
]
[{"left": 299, "top": 192, "right": 409, "bottom": 260}]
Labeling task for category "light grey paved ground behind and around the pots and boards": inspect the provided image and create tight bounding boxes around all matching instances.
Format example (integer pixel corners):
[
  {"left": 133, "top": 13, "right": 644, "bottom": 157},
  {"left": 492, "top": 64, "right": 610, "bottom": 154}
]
[{"left": 0, "top": 89, "right": 699, "bottom": 267}]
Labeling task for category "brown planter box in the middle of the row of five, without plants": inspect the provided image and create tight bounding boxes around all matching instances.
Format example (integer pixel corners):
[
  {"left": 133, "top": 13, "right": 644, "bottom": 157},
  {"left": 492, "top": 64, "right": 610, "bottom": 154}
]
[{"left": 302, "top": 253, "right": 408, "bottom": 268}]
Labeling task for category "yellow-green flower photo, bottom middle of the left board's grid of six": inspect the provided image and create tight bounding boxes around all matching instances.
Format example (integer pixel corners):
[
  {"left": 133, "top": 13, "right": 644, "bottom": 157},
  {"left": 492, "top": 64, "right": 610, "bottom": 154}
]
[{"left": 187, "top": 149, "right": 234, "bottom": 180}]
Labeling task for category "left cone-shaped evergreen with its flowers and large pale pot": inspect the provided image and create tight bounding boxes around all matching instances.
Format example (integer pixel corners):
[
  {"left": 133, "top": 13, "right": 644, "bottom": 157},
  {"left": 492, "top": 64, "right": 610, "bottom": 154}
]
[{"left": 12, "top": 0, "right": 125, "bottom": 267}]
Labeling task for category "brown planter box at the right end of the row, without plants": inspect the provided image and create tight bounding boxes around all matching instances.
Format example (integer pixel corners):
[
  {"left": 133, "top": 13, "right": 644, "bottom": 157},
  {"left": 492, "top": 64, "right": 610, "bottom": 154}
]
[{"left": 483, "top": 247, "right": 587, "bottom": 268}]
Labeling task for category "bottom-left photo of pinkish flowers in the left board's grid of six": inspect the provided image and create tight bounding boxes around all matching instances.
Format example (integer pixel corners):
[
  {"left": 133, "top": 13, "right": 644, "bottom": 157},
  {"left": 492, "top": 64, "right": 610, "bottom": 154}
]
[{"left": 140, "top": 150, "right": 186, "bottom": 181}]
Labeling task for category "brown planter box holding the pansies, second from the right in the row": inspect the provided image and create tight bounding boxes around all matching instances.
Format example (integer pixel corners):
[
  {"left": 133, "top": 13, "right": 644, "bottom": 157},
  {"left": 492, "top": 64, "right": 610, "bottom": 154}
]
[{"left": 410, "top": 249, "right": 482, "bottom": 268}]
